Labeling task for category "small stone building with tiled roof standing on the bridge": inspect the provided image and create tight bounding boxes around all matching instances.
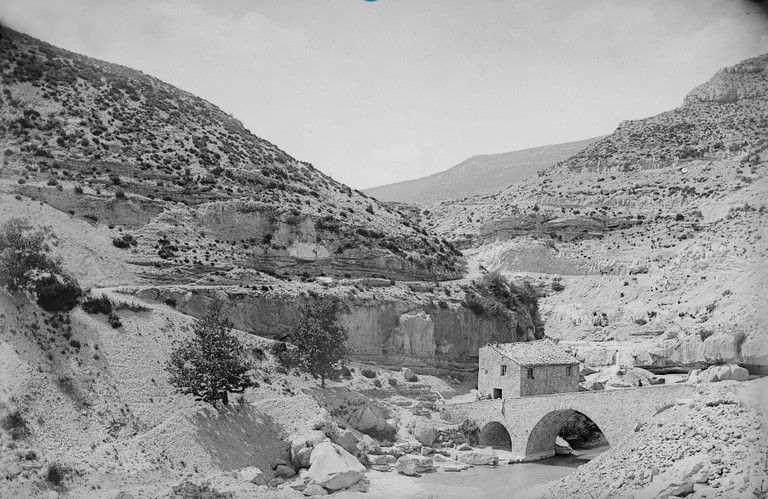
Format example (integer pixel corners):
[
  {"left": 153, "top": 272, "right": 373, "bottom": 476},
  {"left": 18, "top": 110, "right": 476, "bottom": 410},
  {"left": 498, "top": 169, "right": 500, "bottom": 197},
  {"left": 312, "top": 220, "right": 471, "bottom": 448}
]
[{"left": 477, "top": 339, "right": 579, "bottom": 398}]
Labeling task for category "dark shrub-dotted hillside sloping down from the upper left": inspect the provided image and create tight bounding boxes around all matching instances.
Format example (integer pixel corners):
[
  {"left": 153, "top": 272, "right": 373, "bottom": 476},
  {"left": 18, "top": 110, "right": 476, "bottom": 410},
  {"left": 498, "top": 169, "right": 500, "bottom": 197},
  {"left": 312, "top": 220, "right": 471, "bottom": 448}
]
[{"left": 0, "top": 29, "right": 464, "bottom": 282}]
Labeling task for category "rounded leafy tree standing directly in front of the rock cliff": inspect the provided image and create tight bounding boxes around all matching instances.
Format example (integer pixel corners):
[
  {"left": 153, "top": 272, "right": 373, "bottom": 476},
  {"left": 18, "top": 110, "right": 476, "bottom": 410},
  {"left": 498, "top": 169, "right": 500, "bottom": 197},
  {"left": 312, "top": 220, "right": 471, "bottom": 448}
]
[{"left": 291, "top": 299, "right": 349, "bottom": 388}]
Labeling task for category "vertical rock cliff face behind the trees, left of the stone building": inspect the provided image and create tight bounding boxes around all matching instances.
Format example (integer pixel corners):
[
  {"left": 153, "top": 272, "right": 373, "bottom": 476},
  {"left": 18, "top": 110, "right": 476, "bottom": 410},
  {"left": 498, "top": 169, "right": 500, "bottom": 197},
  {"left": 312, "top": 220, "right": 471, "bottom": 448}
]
[{"left": 130, "top": 286, "right": 534, "bottom": 370}]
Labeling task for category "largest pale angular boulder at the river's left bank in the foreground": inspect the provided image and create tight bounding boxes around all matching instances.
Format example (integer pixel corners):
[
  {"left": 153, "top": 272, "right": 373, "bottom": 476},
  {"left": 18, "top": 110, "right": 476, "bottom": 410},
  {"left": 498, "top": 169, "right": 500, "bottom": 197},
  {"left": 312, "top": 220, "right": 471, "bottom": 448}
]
[{"left": 307, "top": 442, "right": 365, "bottom": 490}]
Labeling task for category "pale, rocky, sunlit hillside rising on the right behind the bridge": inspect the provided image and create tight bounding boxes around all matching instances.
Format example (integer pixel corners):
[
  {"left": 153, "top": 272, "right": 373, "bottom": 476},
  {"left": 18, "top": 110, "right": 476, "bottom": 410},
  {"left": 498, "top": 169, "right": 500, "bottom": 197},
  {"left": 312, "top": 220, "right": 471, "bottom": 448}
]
[{"left": 425, "top": 55, "right": 768, "bottom": 369}]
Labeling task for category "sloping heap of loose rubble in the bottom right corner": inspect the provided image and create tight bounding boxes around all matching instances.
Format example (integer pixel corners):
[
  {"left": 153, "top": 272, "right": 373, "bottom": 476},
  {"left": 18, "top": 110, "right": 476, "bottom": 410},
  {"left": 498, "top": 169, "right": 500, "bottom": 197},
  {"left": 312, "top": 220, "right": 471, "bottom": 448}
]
[{"left": 545, "top": 384, "right": 768, "bottom": 499}]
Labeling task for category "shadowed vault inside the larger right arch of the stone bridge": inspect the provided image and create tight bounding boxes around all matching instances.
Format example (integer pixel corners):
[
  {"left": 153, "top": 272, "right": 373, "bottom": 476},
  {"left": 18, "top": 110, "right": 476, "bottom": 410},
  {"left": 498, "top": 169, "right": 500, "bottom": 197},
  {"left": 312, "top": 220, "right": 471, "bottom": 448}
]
[{"left": 525, "top": 409, "right": 608, "bottom": 459}]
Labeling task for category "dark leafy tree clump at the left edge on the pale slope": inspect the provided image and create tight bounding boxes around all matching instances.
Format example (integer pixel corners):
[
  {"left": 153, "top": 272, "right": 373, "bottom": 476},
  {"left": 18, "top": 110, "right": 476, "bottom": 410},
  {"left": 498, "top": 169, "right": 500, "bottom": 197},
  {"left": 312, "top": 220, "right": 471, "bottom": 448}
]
[{"left": 0, "top": 218, "right": 82, "bottom": 312}]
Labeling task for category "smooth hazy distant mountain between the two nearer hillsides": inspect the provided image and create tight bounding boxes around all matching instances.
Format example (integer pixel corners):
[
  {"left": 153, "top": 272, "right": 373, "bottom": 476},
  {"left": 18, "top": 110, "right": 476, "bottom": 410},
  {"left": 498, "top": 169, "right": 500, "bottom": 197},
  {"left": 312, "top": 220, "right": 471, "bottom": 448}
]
[{"left": 363, "top": 137, "right": 603, "bottom": 204}]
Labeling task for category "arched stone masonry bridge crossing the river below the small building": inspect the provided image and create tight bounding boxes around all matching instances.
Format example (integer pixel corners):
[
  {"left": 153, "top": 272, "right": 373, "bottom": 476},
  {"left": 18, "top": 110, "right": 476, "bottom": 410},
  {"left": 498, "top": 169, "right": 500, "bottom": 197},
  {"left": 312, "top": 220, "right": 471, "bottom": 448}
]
[{"left": 441, "top": 383, "right": 696, "bottom": 461}]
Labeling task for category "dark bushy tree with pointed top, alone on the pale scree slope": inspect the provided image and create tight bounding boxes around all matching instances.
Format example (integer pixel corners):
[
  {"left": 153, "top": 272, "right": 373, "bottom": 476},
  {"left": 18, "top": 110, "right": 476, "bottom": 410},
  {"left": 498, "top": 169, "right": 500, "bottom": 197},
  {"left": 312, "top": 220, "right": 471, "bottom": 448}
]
[{"left": 165, "top": 302, "right": 253, "bottom": 405}]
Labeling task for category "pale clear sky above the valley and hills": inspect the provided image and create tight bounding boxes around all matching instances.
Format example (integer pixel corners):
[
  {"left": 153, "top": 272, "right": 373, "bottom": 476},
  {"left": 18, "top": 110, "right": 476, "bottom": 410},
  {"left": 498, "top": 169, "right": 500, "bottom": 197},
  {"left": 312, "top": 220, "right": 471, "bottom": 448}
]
[{"left": 0, "top": 0, "right": 768, "bottom": 188}]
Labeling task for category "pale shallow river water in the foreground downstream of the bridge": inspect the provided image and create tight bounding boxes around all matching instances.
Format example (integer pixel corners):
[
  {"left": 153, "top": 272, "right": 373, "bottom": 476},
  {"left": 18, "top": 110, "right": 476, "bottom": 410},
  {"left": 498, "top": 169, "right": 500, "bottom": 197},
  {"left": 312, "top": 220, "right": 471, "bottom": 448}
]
[{"left": 352, "top": 447, "right": 607, "bottom": 499}]
